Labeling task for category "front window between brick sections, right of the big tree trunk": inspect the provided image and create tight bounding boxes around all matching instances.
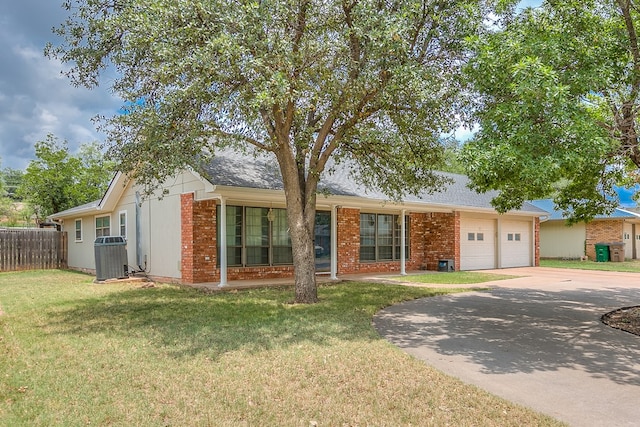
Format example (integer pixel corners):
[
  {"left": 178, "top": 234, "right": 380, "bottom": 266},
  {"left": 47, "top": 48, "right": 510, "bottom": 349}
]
[{"left": 360, "top": 213, "right": 409, "bottom": 261}]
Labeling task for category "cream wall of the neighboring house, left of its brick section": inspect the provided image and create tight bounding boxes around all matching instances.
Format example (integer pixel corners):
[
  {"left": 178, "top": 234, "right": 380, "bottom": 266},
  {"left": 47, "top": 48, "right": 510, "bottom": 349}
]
[{"left": 540, "top": 221, "right": 586, "bottom": 259}]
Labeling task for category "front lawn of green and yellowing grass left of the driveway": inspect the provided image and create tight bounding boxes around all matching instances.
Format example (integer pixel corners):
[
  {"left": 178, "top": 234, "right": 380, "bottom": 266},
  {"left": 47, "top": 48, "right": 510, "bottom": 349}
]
[{"left": 0, "top": 271, "right": 558, "bottom": 427}]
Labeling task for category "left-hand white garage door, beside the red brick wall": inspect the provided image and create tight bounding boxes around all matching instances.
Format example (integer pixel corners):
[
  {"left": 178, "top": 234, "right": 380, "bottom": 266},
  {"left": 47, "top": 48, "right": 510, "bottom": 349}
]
[{"left": 460, "top": 218, "right": 496, "bottom": 270}]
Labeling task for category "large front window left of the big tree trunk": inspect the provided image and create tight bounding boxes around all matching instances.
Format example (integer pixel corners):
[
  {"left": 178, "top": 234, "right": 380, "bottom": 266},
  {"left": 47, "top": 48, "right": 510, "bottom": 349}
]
[{"left": 217, "top": 206, "right": 293, "bottom": 266}]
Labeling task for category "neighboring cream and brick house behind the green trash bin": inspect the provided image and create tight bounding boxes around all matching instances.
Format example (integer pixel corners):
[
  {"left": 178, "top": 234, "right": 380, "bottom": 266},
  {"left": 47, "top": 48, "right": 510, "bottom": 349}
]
[{"left": 531, "top": 199, "right": 640, "bottom": 260}]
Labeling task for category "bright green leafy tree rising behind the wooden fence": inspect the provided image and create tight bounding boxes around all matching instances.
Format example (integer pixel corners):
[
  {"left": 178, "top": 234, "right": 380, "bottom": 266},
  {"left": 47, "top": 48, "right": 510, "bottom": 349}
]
[{"left": 18, "top": 134, "right": 113, "bottom": 220}]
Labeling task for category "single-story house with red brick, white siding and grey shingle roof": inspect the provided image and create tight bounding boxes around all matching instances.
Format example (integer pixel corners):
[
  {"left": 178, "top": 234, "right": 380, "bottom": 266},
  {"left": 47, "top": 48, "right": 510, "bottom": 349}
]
[{"left": 53, "top": 152, "right": 547, "bottom": 284}]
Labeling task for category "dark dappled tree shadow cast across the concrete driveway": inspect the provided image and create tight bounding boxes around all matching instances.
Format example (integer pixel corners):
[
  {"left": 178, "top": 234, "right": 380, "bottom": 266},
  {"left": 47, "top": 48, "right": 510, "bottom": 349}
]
[{"left": 374, "top": 288, "right": 640, "bottom": 385}]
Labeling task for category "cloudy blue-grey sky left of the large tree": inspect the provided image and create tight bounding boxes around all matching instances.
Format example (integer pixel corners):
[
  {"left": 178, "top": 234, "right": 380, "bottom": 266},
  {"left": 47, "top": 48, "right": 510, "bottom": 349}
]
[{"left": 0, "top": 0, "right": 121, "bottom": 169}]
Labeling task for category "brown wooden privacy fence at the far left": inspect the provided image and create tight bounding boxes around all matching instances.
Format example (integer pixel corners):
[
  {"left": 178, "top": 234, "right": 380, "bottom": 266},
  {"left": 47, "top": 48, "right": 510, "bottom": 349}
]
[{"left": 0, "top": 228, "right": 67, "bottom": 271}]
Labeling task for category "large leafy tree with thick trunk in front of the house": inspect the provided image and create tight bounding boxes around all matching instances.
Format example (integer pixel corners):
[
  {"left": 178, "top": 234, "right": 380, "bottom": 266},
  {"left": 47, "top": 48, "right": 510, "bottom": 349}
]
[{"left": 48, "top": 0, "right": 505, "bottom": 303}]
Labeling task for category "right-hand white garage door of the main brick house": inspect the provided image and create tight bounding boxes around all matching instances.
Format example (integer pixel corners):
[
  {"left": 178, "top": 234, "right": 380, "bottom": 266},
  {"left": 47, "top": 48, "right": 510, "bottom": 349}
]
[{"left": 500, "top": 221, "right": 532, "bottom": 268}]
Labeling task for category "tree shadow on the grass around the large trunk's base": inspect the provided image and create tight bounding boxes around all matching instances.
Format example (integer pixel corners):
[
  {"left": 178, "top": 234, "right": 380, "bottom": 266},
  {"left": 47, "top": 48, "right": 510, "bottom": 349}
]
[{"left": 47, "top": 283, "right": 450, "bottom": 359}]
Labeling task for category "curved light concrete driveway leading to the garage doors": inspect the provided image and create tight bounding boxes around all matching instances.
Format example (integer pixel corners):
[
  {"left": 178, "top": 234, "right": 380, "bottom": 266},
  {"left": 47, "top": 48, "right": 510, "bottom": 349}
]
[{"left": 374, "top": 267, "right": 640, "bottom": 426}]
